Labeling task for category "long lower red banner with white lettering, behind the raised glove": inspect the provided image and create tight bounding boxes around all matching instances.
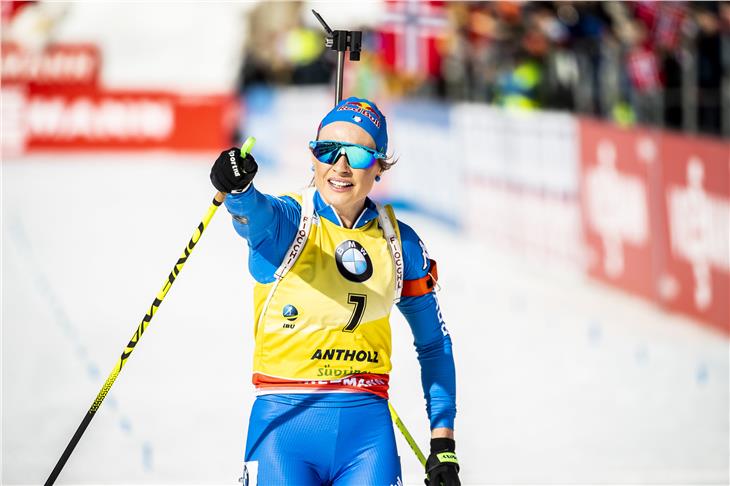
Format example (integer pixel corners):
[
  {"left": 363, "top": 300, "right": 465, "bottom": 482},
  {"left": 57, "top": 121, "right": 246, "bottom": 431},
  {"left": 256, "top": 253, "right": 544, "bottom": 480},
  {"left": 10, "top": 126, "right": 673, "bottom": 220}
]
[{"left": 3, "top": 89, "right": 238, "bottom": 153}]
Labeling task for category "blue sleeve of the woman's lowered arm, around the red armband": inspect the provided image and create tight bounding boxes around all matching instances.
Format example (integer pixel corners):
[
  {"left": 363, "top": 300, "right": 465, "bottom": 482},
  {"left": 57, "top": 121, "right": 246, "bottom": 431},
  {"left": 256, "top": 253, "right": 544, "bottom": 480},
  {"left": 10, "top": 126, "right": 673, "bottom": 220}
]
[{"left": 398, "top": 222, "right": 456, "bottom": 429}]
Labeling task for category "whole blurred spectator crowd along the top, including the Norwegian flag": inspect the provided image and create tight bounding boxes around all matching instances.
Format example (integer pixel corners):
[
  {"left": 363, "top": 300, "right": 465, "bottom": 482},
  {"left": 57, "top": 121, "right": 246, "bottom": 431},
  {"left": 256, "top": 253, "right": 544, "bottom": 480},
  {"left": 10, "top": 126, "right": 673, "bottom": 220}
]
[{"left": 240, "top": 0, "right": 730, "bottom": 136}]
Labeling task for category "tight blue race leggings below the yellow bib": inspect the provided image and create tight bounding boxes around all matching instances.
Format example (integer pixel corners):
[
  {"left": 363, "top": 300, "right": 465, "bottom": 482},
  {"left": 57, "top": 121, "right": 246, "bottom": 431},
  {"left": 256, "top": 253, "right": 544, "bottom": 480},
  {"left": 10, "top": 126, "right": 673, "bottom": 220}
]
[{"left": 243, "top": 393, "right": 402, "bottom": 486}]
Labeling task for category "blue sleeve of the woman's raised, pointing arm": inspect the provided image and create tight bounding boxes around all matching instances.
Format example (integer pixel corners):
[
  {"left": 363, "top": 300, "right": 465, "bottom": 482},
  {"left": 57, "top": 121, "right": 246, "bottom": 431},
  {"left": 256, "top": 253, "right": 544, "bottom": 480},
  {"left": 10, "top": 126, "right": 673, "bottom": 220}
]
[{"left": 225, "top": 184, "right": 301, "bottom": 283}]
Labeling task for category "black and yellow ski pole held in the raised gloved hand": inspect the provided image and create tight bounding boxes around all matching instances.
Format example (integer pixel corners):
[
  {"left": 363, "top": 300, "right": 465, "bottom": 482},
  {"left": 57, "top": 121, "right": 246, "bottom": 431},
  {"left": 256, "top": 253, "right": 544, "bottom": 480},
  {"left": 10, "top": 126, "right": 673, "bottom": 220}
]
[{"left": 45, "top": 137, "right": 256, "bottom": 486}]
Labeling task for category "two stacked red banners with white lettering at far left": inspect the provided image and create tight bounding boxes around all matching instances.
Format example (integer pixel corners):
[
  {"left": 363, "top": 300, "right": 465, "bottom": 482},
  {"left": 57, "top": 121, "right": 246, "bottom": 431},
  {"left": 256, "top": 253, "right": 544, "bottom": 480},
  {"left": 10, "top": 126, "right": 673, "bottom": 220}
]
[{"left": 2, "top": 43, "right": 239, "bottom": 155}]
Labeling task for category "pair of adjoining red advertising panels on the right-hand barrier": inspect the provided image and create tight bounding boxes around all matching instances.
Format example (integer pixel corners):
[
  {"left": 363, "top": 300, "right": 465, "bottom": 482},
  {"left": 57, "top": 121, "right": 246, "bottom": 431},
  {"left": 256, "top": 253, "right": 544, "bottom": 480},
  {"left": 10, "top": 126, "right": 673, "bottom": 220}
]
[{"left": 579, "top": 120, "right": 730, "bottom": 334}]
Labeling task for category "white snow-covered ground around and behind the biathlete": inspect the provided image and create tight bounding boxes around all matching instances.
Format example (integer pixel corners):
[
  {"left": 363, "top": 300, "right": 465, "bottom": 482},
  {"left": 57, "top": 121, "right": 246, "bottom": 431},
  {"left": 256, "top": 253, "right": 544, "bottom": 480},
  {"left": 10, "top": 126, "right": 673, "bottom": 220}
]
[{"left": 1, "top": 157, "right": 730, "bottom": 484}]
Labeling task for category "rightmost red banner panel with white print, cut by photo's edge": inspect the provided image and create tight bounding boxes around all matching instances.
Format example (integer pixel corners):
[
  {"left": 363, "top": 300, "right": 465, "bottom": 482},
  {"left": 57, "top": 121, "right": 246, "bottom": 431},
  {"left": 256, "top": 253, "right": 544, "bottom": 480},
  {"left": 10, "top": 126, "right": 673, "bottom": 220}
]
[{"left": 657, "top": 134, "right": 730, "bottom": 334}]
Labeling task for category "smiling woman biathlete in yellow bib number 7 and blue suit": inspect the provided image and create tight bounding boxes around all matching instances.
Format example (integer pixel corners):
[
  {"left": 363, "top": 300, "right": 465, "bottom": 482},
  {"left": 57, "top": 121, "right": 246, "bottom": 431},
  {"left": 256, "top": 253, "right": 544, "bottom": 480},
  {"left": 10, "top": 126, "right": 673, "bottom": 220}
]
[{"left": 210, "top": 98, "right": 460, "bottom": 486}]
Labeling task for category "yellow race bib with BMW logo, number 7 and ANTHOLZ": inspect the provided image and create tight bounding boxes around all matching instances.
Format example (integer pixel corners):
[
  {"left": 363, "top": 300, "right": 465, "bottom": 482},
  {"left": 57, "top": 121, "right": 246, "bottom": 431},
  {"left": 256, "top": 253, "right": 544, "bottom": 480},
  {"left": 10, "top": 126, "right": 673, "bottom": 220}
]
[{"left": 253, "top": 191, "right": 397, "bottom": 396}]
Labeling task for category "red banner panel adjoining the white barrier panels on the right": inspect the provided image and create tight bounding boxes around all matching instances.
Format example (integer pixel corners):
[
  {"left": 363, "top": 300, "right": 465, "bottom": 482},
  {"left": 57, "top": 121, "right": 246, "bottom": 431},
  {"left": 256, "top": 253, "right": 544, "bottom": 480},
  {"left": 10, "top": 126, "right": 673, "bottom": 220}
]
[{"left": 578, "top": 119, "right": 658, "bottom": 299}]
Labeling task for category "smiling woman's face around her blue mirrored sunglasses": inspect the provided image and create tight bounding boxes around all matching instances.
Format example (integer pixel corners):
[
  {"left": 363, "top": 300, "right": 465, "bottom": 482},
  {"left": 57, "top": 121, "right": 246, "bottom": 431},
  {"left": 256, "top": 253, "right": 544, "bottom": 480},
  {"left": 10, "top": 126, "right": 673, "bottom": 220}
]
[{"left": 312, "top": 121, "right": 382, "bottom": 227}]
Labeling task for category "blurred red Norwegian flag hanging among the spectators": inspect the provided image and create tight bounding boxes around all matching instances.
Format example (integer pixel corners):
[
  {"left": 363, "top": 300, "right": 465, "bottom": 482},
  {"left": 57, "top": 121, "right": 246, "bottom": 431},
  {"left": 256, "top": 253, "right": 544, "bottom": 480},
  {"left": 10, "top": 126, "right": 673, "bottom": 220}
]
[{"left": 380, "top": 0, "right": 448, "bottom": 76}]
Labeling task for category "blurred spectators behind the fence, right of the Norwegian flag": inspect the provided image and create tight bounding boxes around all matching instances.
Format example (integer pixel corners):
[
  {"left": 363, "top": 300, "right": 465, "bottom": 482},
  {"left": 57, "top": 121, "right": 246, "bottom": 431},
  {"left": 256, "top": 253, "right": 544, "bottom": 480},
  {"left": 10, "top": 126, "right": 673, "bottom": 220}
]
[{"left": 443, "top": 1, "right": 730, "bottom": 134}]
